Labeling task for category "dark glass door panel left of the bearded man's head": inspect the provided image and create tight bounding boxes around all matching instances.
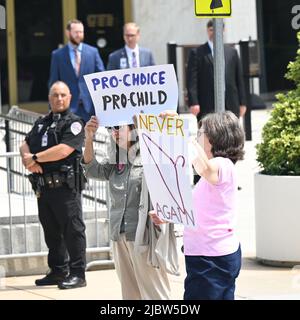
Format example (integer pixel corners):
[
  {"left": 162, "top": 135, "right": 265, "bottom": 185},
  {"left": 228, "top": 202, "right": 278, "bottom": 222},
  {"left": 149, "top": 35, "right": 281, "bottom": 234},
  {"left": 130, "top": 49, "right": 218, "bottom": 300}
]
[{"left": 15, "top": 0, "right": 63, "bottom": 112}]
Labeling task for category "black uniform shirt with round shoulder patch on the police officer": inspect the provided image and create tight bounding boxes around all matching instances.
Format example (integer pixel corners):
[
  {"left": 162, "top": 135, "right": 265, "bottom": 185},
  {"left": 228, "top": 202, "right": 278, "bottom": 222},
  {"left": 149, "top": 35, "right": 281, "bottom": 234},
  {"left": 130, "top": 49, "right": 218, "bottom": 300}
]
[{"left": 25, "top": 109, "right": 84, "bottom": 173}]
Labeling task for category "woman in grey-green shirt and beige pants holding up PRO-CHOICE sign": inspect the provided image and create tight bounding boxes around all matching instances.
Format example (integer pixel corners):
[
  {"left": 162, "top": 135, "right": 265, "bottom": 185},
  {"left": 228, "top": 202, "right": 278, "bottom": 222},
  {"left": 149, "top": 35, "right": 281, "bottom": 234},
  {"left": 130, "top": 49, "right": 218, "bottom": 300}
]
[{"left": 84, "top": 116, "right": 178, "bottom": 300}]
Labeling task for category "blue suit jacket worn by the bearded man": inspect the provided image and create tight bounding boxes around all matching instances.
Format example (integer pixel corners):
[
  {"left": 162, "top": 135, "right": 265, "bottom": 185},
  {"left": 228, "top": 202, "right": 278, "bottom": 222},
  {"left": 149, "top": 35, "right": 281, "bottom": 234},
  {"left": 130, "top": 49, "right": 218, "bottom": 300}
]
[{"left": 49, "top": 43, "right": 104, "bottom": 122}]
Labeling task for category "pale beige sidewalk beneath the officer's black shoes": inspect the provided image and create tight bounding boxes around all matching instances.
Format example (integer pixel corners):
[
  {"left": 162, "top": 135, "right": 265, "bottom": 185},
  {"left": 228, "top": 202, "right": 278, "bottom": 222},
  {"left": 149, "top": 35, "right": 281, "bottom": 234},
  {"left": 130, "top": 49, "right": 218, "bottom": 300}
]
[{"left": 0, "top": 250, "right": 300, "bottom": 301}]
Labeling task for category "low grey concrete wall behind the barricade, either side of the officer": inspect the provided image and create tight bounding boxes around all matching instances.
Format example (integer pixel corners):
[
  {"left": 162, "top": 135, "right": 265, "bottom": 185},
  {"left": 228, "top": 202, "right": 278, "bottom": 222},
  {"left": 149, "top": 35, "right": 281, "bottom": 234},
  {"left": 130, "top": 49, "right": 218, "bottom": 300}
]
[{"left": 0, "top": 210, "right": 113, "bottom": 280}]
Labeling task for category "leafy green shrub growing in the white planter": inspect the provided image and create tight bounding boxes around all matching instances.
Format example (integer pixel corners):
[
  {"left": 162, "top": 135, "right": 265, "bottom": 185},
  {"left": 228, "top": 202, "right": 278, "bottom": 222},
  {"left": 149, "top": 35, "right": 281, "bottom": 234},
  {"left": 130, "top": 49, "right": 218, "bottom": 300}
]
[{"left": 256, "top": 32, "right": 300, "bottom": 175}]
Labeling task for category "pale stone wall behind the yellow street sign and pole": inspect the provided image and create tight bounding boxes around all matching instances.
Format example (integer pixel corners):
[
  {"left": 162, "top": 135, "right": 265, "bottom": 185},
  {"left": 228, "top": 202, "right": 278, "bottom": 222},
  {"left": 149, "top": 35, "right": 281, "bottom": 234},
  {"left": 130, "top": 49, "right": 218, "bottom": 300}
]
[{"left": 132, "top": 0, "right": 257, "bottom": 64}]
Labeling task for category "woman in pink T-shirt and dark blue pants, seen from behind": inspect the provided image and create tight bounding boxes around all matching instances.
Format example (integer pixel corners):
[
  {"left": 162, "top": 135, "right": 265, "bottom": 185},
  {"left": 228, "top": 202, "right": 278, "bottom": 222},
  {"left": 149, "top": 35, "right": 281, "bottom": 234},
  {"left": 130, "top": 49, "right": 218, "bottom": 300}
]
[{"left": 151, "top": 111, "right": 244, "bottom": 300}]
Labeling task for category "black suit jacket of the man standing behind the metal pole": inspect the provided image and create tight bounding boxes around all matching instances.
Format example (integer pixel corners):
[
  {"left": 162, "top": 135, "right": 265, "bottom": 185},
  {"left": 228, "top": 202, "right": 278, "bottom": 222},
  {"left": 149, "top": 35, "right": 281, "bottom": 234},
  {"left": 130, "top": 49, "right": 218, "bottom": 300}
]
[{"left": 187, "top": 43, "right": 246, "bottom": 119}]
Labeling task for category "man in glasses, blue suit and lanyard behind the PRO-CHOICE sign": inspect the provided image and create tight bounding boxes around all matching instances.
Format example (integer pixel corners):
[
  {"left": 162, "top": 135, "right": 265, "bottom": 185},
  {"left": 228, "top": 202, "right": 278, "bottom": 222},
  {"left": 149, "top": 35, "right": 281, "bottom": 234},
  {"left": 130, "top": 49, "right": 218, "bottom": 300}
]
[{"left": 107, "top": 22, "right": 155, "bottom": 70}]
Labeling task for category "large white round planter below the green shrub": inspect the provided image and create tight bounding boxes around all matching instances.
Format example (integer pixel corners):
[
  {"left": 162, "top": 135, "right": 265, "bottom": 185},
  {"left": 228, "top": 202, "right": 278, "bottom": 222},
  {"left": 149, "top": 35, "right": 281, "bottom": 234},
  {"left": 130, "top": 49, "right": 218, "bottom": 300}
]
[{"left": 254, "top": 174, "right": 300, "bottom": 266}]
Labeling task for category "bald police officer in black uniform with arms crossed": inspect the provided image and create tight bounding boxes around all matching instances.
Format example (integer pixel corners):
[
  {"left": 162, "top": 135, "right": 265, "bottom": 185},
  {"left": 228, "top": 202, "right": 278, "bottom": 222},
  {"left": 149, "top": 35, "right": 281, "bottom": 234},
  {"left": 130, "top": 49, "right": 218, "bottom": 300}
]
[{"left": 20, "top": 81, "right": 86, "bottom": 289}]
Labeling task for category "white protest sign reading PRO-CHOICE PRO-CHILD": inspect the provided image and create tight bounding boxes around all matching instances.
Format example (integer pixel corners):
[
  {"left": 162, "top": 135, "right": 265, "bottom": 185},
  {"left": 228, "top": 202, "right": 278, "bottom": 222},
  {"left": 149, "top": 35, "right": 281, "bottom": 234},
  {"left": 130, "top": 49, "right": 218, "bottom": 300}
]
[{"left": 84, "top": 64, "right": 178, "bottom": 126}]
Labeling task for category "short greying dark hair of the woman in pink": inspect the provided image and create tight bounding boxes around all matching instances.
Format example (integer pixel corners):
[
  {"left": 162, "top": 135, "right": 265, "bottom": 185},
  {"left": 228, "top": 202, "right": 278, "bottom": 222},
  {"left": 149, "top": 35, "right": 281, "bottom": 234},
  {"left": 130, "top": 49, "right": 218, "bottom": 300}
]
[{"left": 199, "top": 111, "right": 245, "bottom": 163}]
